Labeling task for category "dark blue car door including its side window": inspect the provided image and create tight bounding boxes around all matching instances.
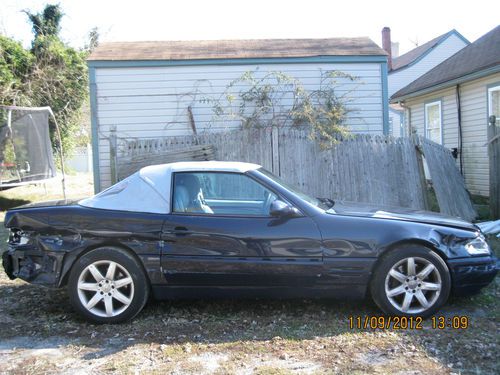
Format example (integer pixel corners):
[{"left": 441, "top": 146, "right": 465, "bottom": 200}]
[{"left": 161, "top": 172, "right": 322, "bottom": 287}]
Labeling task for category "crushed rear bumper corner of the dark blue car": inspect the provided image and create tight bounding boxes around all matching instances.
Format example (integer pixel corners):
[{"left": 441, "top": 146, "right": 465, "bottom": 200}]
[{"left": 2, "top": 245, "right": 64, "bottom": 287}]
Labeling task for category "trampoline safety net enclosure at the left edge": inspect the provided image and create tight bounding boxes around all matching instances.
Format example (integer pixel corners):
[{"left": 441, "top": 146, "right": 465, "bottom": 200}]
[{"left": 0, "top": 107, "right": 56, "bottom": 188}]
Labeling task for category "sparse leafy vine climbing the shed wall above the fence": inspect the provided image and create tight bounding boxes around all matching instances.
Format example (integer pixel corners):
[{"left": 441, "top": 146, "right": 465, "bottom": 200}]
[{"left": 202, "top": 71, "right": 357, "bottom": 148}]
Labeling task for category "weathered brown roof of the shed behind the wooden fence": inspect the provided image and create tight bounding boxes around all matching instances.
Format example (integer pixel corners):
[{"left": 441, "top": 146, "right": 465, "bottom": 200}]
[{"left": 88, "top": 37, "right": 387, "bottom": 61}]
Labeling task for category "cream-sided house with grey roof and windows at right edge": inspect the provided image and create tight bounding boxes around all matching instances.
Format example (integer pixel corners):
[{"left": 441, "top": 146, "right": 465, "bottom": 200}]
[{"left": 391, "top": 26, "right": 500, "bottom": 196}]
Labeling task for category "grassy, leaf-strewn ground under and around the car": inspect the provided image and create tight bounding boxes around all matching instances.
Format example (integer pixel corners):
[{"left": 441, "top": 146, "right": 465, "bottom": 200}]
[{"left": 0, "top": 175, "right": 500, "bottom": 374}]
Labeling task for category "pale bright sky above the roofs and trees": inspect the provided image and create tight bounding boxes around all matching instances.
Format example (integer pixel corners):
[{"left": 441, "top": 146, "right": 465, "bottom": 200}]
[{"left": 0, "top": 0, "right": 500, "bottom": 54}]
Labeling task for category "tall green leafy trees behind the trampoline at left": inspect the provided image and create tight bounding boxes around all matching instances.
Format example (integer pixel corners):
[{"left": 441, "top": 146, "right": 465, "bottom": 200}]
[{"left": 0, "top": 5, "right": 90, "bottom": 153}]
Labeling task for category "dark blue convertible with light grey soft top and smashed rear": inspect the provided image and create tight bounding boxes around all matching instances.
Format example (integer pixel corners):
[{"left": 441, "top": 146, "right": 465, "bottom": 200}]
[{"left": 3, "top": 162, "right": 497, "bottom": 323}]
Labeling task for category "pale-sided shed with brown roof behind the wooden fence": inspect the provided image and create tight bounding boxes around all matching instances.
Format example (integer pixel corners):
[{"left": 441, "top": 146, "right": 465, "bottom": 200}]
[{"left": 88, "top": 38, "right": 388, "bottom": 191}]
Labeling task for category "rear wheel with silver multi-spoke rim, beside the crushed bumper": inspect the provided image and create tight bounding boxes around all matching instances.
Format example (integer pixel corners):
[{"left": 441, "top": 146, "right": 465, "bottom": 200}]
[{"left": 68, "top": 247, "right": 150, "bottom": 324}]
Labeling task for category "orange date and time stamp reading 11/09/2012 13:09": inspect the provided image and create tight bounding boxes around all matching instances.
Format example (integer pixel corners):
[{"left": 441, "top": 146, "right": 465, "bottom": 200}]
[{"left": 348, "top": 315, "right": 469, "bottom": 330}]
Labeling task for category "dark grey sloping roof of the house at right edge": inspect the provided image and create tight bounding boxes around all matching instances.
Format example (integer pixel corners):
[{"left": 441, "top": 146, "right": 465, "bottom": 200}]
[{"left": 391, "top": 25, "right": 500, "bottom": 100}]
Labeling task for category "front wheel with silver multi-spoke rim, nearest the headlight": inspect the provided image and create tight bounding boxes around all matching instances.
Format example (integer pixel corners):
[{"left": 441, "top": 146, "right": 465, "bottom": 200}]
[{"left": 370, "top": 245, "right": 451, "bottom": 318}]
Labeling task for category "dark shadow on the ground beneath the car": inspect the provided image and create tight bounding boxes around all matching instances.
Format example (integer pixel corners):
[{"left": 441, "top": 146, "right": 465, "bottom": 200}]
[{"left": 0, "top": 281, "right": 379, "bottom": 345}]
